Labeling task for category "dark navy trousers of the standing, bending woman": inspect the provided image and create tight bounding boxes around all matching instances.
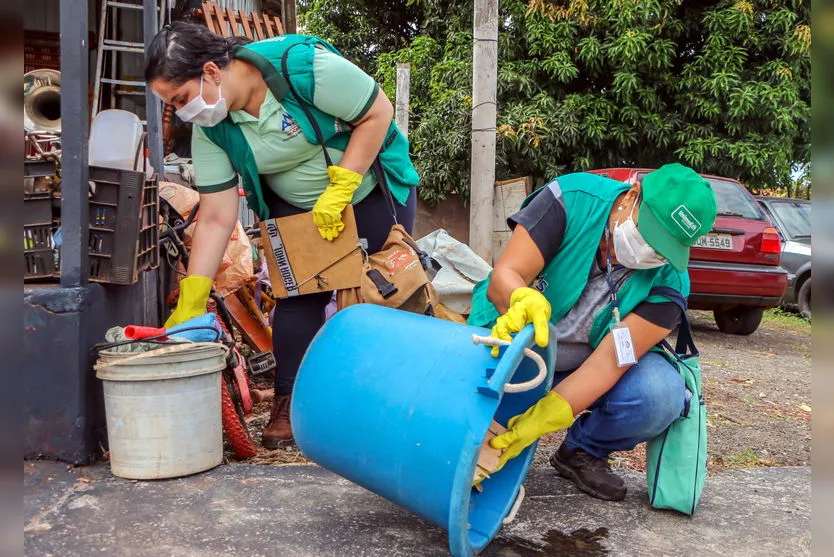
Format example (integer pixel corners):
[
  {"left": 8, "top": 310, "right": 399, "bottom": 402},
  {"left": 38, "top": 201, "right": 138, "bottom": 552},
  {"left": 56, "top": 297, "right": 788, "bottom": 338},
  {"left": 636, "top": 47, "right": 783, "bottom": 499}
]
[{"left": 265, "top": 186, "right": 417, "bottom": 396}]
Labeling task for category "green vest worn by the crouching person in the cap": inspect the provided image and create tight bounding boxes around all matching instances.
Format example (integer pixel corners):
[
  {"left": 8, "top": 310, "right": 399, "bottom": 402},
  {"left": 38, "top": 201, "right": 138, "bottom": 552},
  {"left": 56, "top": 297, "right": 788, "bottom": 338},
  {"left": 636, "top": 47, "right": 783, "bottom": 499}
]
[{"left": 469, "top": 172, "right": 689, "bottom": 348}]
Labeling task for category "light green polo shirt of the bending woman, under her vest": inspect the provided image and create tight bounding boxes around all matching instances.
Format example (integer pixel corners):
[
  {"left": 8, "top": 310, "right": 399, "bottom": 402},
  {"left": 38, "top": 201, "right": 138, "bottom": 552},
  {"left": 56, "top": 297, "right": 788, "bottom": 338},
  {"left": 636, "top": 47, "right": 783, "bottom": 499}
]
[{"left": 191, "top": 47, "right": 377, "bottom": 210}]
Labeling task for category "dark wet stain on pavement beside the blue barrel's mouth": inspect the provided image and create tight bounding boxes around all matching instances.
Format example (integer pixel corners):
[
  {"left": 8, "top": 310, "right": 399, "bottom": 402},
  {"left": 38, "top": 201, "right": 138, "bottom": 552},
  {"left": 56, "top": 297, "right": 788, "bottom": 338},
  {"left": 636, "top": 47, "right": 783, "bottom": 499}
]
[{"left": 487, "top": 527, "right": 609, "bottom": 557}]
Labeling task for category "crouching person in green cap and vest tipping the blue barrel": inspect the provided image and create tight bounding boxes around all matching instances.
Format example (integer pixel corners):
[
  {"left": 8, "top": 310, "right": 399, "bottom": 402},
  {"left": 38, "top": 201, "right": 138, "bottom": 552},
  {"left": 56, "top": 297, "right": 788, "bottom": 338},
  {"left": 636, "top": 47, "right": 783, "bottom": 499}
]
[{"left": 469, "top": 164, "right": 716, "bottom": 501}]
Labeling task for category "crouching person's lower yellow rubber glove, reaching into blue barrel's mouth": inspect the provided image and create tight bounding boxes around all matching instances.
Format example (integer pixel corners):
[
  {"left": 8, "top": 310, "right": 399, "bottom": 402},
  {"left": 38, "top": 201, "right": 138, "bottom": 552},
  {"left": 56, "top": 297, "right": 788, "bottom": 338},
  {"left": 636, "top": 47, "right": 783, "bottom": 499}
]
[{"left": 489, "top": 391, "right": 573, "bottom": 472}]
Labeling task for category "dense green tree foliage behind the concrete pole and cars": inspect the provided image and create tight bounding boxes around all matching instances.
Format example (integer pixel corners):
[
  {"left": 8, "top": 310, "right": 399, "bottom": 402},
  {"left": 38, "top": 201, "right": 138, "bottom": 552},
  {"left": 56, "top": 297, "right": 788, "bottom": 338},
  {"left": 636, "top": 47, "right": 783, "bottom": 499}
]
[{"left": 299, "top": 0, "right": 811, "bottom": 202}]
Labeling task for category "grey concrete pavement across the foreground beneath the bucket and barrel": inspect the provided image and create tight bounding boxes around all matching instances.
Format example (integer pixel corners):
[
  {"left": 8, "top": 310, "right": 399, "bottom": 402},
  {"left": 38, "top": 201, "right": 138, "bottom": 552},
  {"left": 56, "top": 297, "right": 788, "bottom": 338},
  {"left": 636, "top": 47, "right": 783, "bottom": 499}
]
[{"left": 23, "top": 462, "right": 811, "bottom": 557}]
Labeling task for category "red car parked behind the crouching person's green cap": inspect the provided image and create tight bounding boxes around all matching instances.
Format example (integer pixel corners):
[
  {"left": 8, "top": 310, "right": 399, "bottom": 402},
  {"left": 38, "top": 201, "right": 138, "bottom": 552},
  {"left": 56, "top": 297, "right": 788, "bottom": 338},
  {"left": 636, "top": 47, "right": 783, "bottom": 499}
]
[{"left": 591, "top": 168, "right": 788, "bottom": 335}]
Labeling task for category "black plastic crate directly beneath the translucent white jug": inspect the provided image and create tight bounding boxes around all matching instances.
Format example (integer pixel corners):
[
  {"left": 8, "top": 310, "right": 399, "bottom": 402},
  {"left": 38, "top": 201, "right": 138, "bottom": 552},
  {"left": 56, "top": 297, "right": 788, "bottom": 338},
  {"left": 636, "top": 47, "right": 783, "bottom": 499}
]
[{"left": 88, "top": 166, "right": 159, "bottom": 284}]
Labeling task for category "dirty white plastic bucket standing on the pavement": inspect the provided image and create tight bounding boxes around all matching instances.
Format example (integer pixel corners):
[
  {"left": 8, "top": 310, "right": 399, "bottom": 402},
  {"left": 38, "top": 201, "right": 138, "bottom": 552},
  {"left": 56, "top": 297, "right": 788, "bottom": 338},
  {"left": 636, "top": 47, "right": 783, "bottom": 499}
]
[{"left": 95, "top": 343, "right": 227, "bottom": 480}]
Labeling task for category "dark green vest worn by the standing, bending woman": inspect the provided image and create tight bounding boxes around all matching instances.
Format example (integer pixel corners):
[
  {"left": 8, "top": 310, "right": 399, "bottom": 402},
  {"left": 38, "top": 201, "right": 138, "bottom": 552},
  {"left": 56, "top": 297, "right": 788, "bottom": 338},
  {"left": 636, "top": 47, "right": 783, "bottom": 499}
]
[{"left": 203, "top": 35, "right": 419, "bottom": 219}]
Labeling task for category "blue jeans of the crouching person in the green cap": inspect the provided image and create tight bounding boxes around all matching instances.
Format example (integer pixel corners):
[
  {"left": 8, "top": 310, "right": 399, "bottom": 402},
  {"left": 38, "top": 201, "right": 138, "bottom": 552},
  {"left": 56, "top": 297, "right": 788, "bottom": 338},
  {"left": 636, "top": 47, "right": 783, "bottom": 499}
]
[{"left": 554, "top": 352, "right": 686, "bottom": 458}]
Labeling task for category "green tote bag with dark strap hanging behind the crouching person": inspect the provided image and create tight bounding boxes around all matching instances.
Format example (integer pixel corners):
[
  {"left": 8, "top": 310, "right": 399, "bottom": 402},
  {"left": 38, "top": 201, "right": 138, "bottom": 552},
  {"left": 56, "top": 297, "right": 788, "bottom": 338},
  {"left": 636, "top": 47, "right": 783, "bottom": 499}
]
[{"left": 646, "top": 311, "right": 707, "bottom": 515}]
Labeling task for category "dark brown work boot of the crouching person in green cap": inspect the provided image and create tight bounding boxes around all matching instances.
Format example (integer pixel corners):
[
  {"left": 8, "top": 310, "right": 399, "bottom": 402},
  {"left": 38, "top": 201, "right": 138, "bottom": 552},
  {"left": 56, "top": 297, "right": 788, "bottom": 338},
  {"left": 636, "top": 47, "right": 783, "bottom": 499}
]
[{"left": 550, "top": 443, "right": 626, "bottom": 501}]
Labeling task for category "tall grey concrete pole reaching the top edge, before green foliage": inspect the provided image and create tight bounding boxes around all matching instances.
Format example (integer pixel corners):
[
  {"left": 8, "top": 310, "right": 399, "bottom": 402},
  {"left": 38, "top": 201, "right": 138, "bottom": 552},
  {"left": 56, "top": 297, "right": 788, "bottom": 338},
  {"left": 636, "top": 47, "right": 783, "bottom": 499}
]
[{"left": 469, "top": 0, "right": 498, "bottom": 264}]
